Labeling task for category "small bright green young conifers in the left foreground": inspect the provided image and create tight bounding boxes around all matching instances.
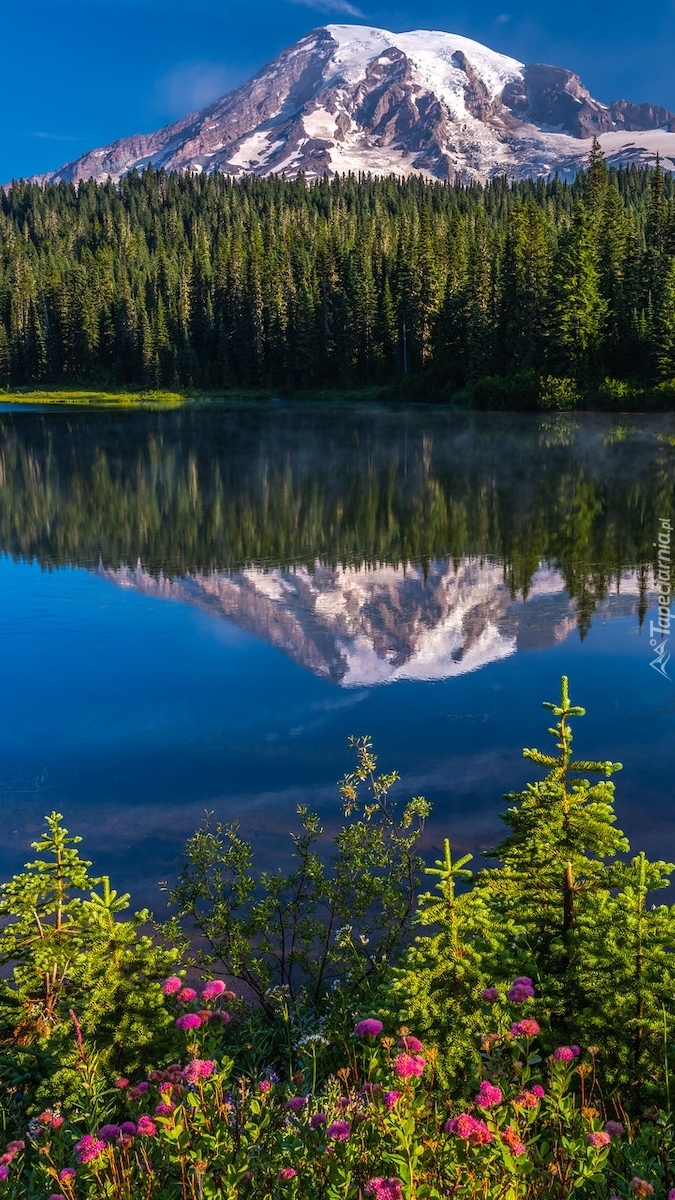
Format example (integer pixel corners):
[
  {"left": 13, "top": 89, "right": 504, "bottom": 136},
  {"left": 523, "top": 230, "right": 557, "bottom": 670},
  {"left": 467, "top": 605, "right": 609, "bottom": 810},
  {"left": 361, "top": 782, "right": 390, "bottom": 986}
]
[{"left": 0, "top": 812, "right": 181, "bottom": 1105}]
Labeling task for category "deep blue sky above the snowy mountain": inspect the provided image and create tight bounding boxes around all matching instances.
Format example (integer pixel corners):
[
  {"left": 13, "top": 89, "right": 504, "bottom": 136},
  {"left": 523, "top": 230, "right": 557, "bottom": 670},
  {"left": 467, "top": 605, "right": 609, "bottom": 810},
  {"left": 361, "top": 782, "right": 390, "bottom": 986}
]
[{"left": 0, "top": 0, "right": 675, "bottom": 181}]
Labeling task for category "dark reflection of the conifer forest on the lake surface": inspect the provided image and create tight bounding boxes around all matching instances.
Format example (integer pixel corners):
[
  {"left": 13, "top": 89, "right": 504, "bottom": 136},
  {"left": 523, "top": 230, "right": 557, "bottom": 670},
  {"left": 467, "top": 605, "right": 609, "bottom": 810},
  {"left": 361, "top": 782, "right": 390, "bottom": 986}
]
[{"left": 0, "top": 404, "right": 675, "bottom": 631}]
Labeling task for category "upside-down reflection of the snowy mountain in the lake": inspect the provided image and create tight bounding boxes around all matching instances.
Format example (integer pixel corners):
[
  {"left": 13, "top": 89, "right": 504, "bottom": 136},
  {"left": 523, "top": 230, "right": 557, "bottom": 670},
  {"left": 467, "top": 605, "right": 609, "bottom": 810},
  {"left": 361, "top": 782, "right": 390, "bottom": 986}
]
[{"left": 98, "top": 557, "right": 639, "bottom": 688}]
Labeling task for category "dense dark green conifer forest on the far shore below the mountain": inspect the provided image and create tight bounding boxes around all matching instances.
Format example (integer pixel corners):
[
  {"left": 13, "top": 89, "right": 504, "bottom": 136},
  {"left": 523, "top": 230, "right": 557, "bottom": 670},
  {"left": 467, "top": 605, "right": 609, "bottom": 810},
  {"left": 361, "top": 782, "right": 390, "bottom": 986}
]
[{"left": 0, "top": 149, "right": 675, "bottom": 407}]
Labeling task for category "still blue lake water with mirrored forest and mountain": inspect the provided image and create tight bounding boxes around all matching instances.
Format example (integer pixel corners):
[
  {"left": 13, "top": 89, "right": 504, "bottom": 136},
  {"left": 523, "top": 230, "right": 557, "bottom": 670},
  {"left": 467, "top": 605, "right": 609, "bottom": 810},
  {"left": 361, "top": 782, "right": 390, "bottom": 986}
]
[{"left": 0, "top": 403, "right": 675, "bottom": 911}]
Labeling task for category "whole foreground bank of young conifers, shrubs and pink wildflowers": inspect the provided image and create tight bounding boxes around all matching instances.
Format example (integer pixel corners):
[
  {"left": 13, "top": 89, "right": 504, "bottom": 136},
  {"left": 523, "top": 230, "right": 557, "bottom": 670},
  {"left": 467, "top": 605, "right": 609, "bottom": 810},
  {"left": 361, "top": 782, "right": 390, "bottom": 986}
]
[{"left": 0, "top": 678, "right": 675, "bottom": 1200}]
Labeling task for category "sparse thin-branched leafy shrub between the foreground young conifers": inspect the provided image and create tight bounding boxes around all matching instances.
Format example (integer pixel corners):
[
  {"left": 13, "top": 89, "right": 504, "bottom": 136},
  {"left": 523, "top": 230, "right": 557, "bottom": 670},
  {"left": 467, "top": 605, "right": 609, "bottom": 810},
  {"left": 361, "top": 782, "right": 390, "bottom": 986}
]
[{"left": 172, "top": 738, "right": 429, "bottom": 1074}]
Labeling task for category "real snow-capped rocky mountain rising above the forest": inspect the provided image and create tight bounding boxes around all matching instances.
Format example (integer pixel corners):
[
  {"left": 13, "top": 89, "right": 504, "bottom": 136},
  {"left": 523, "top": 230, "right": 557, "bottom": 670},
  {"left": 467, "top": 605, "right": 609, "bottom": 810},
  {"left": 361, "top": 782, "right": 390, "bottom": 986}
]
[{"left": 28, "top": 25, "right": 675, "bottom": 182}]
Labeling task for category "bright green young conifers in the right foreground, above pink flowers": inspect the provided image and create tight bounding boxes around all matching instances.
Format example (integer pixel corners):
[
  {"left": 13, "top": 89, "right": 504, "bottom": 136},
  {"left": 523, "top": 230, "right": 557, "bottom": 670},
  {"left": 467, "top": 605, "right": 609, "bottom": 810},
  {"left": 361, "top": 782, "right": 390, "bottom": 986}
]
[{"left": 395, "top": 677, "right": 675, "bottom": 1103}]
